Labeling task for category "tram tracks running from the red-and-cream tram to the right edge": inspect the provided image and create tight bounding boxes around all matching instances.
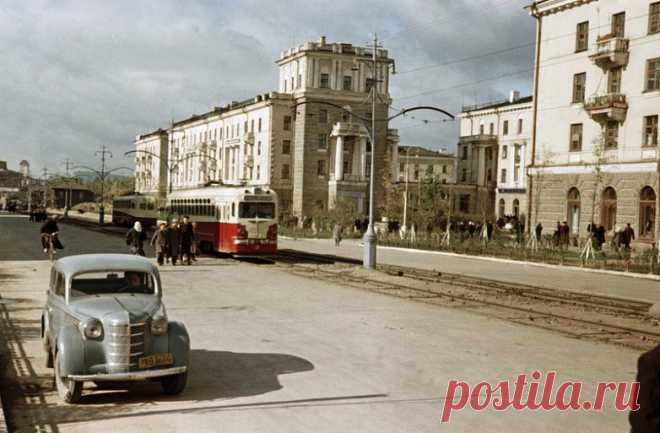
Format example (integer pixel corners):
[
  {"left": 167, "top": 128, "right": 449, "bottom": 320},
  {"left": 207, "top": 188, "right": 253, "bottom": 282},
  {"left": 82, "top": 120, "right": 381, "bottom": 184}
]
[{"left": 273, "top": 250, "right": 660, "bottom": 350}]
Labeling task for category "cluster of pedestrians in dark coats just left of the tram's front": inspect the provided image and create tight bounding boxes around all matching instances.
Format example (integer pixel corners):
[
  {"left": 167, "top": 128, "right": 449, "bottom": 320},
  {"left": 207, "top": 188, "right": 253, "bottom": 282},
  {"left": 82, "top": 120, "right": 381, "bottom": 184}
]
[{"left": 126, "top": 216, "right": 198, "bottom": 266}]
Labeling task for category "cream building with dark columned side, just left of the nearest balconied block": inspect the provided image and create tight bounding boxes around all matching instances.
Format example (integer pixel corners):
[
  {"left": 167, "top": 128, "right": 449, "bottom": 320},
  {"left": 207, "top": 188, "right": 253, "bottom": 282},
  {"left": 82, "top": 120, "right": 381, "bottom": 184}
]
[{"left": 455, "top": 91, "right": 532, "bottom": 218}]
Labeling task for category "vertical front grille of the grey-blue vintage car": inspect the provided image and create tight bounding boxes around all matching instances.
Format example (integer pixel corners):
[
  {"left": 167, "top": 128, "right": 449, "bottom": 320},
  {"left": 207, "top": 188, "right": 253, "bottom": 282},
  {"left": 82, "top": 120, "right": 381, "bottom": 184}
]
[{"left": 107, "top": 322, "right": 147, "bottom": 372}]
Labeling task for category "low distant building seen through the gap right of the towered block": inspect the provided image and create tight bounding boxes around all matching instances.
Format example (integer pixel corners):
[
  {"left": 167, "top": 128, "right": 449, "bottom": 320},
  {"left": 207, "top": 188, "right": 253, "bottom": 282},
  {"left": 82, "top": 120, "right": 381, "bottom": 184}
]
[{"left": 393, "top": 146, "right": 456, "bottom": 184}]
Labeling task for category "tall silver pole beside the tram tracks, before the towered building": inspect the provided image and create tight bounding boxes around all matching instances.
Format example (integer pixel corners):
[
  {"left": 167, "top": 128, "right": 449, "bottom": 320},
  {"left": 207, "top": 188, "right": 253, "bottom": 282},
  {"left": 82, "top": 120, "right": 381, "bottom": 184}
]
[{"left": 363, "top": 33, "right": 380, "bottom": 269}]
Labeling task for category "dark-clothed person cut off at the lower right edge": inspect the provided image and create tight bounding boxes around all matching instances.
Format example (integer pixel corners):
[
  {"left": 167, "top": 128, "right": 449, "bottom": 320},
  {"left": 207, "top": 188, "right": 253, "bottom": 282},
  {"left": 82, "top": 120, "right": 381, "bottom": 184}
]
[{"left": 628, "top": 304, "right": 660, "bottom": 433}]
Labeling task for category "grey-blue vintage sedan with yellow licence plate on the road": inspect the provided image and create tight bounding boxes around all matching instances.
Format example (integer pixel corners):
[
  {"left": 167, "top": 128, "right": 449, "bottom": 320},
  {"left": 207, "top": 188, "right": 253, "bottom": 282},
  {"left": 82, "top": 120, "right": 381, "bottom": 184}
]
[{"left": 41, "top": 254, "right": 190, "bottom": 403}]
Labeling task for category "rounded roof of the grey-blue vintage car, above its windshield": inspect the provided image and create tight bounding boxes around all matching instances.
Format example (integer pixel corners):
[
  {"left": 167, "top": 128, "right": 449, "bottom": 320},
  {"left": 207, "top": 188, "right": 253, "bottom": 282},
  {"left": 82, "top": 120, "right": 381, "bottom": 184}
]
[{"left": 53, "top": 254, "right": 158, "bottom": 275}]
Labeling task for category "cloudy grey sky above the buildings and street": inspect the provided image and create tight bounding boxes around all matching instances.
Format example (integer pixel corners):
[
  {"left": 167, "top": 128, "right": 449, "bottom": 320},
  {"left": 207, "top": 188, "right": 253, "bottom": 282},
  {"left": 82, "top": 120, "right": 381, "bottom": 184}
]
[{"left": 0, "top": 0, "right": 534, "bottom": 173}]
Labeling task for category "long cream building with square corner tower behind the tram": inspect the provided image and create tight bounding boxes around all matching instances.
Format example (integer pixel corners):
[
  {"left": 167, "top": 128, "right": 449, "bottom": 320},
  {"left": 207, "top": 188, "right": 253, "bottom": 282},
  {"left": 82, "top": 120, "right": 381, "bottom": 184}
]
[{"left": 131, "top": 37, "right": 398, "bottom": 216}]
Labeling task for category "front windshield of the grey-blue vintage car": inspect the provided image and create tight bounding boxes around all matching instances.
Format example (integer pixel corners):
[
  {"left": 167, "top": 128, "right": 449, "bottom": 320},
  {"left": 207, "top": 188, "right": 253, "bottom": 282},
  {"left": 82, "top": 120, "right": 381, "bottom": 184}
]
[{"left": 71, "top": 271, "right": 156, "bottom": 297}]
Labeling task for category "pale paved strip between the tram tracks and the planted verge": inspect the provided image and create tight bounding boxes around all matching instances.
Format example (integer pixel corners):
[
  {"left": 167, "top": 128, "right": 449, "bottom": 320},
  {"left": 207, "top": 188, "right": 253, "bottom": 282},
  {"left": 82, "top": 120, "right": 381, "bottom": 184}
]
[{"left": 279, "top": 237, "right": 660, "bottom": 303}]
